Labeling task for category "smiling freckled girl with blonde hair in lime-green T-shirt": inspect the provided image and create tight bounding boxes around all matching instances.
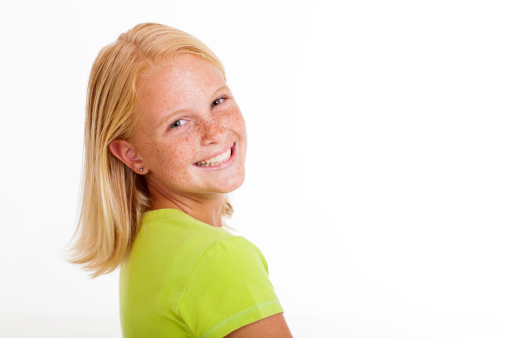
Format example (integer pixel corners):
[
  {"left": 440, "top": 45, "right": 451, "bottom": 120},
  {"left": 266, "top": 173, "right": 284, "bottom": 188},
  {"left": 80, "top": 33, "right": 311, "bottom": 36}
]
[{"left": 73, "top": 24, "right": 292, "bottom": 337}]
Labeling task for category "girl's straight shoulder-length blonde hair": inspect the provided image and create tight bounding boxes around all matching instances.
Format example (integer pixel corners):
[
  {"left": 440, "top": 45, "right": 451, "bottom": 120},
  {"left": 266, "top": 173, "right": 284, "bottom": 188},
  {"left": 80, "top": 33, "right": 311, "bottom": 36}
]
[{"left": 70, "top": 23, "right": 233, "bottom": 277}]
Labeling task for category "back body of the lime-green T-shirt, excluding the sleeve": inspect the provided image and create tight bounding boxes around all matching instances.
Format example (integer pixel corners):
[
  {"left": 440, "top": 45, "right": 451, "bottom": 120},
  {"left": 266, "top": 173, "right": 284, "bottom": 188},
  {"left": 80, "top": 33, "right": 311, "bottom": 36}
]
[{"left": 120, "top": 209, "right": 244, "bottom": 336}]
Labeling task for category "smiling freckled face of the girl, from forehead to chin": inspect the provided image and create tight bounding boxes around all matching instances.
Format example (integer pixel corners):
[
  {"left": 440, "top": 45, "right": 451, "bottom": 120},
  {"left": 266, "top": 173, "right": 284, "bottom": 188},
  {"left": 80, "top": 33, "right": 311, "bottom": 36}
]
[{"left": 132, "top": 54, "right": 246, "bottom": 196}]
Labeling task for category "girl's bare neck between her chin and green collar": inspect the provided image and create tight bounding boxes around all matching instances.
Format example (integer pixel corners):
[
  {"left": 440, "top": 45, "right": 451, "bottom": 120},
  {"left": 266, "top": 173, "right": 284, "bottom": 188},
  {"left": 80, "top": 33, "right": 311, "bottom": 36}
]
[{"left": 148, "top": 182, "right": 226, "bottom": 228}]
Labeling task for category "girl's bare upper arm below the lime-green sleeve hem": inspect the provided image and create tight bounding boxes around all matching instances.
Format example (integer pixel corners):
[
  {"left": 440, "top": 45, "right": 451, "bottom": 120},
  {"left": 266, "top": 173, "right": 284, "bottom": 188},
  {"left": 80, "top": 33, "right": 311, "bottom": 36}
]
[{"left": 225, "top": 313, "right": 292, "bottom": 338}]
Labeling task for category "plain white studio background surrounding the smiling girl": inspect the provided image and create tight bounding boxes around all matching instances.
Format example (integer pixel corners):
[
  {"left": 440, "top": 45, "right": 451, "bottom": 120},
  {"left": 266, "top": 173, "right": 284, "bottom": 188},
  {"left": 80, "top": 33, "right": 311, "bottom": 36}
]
[{"left": 0, "top": 0, "right": 507, "bottom": 338}]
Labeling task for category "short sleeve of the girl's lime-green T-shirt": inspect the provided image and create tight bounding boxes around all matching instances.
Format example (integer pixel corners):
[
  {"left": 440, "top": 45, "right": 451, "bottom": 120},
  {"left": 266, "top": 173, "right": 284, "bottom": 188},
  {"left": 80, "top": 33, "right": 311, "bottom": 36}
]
[{"left": 178, "top": 236, "right": 283, "bottom": 338}]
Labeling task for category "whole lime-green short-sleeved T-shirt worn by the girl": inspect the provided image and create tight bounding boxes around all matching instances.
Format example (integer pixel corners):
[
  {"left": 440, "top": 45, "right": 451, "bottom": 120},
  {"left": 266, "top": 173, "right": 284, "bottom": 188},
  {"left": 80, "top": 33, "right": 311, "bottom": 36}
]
[{"left": 120, "top": 209, "right": 283, "bottom": 338}]
